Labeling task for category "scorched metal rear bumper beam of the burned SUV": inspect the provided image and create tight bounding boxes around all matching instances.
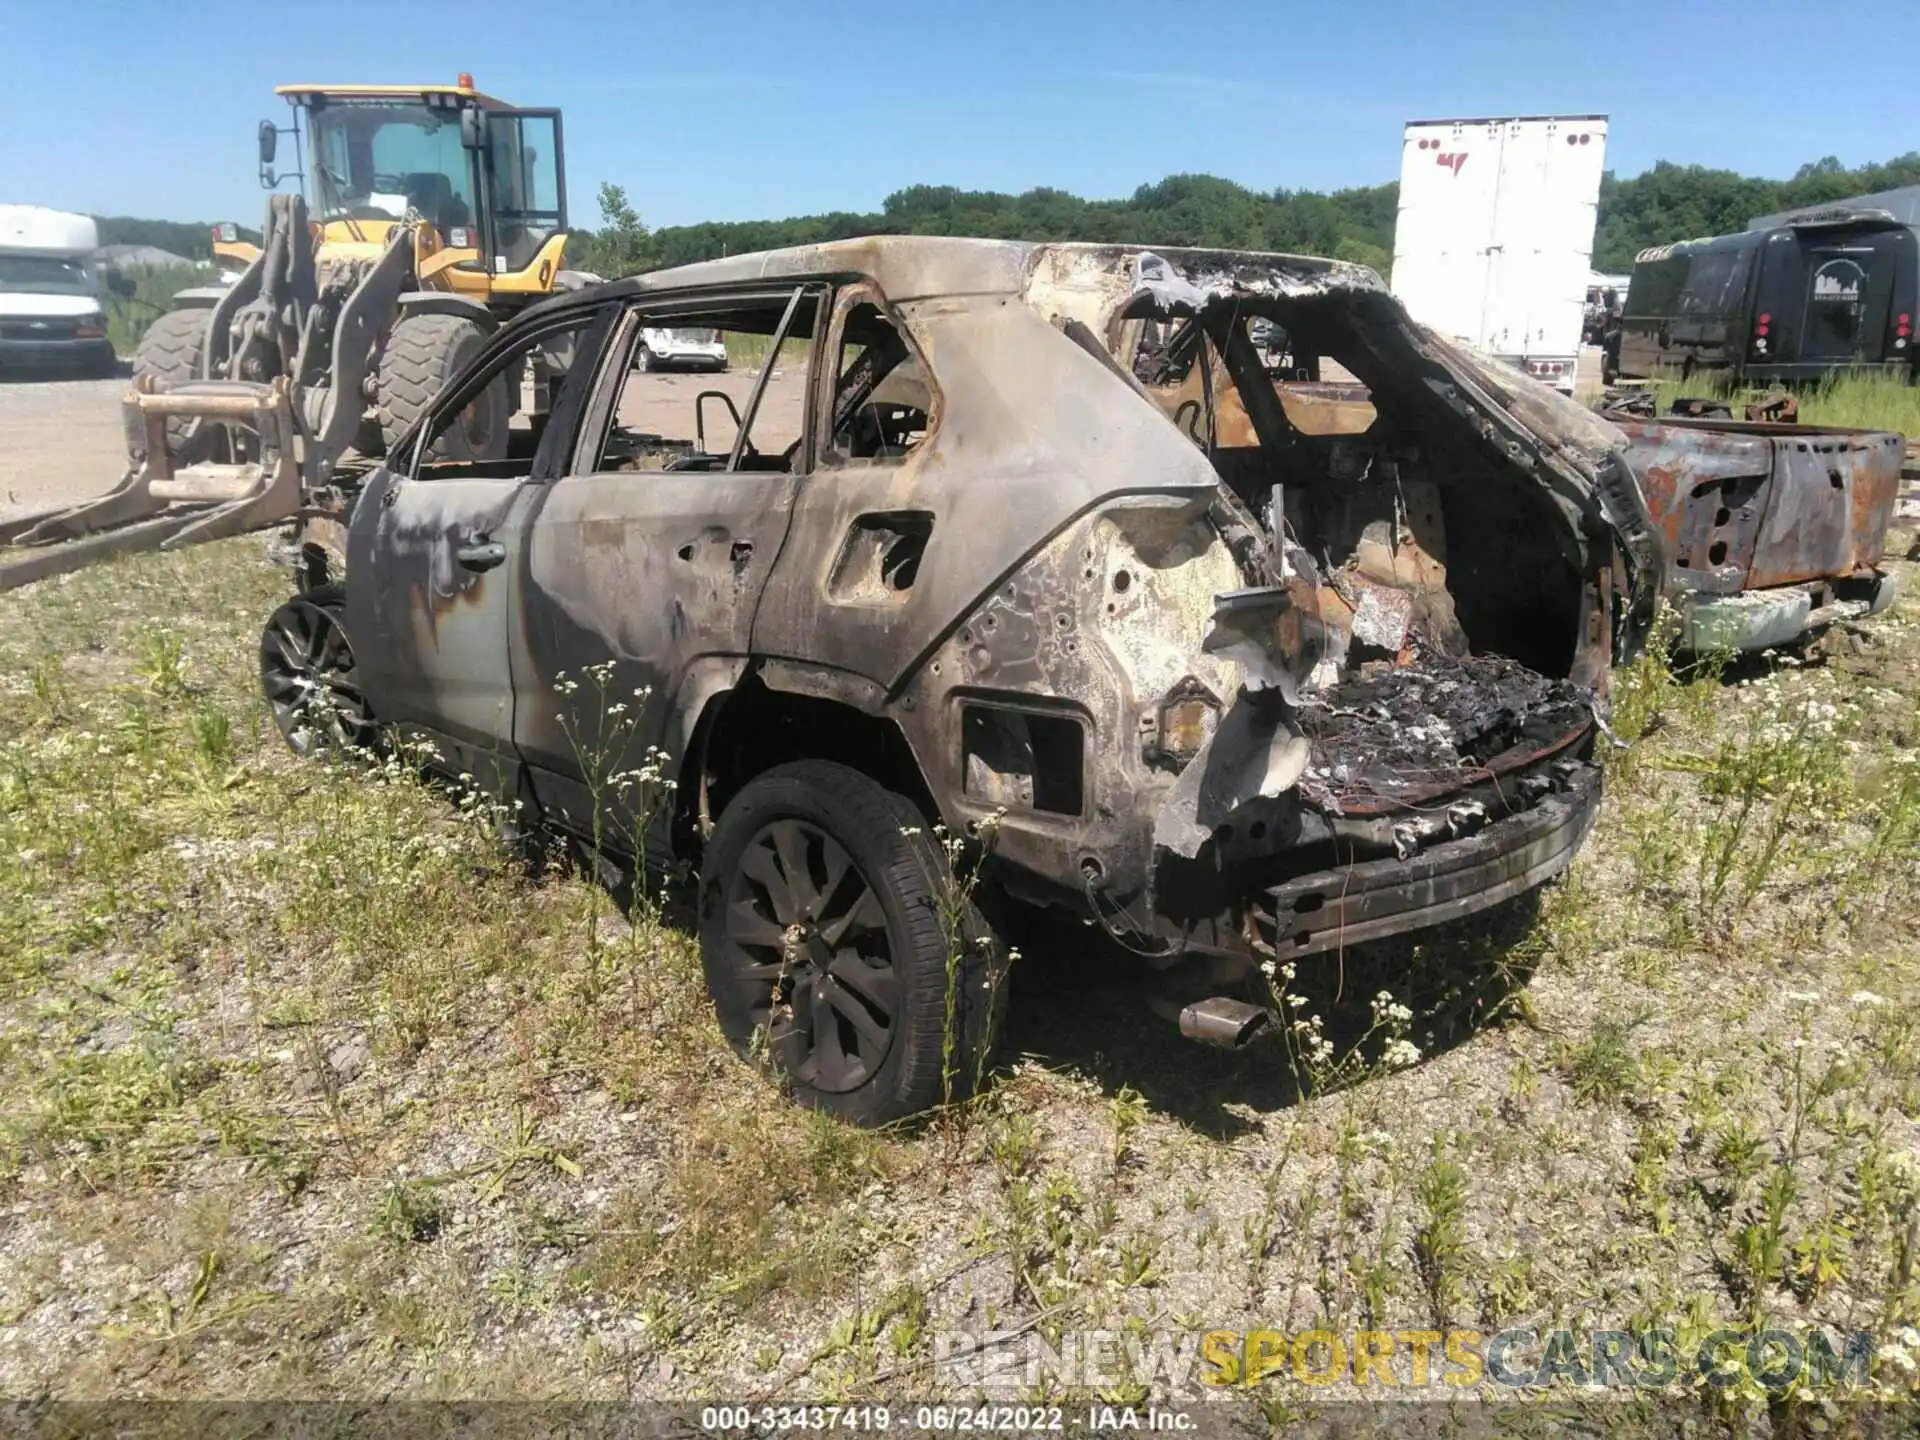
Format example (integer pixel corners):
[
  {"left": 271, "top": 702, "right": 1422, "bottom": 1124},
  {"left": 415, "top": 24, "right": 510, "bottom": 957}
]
[{"left": 1252, "top": 762, "right": 1601, "bottom": 960}]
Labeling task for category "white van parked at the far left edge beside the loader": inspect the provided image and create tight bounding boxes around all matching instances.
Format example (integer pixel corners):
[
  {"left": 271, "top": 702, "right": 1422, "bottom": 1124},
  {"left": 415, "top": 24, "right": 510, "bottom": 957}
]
[{"left": 0, "top": 205, "right": 117, "bottom": 376}]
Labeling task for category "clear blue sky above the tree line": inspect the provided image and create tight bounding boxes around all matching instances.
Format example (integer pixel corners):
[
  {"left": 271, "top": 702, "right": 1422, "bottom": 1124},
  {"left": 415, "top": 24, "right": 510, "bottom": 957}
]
[{"left": 0, "top": 0, "right": 1920, "bottom": 225}]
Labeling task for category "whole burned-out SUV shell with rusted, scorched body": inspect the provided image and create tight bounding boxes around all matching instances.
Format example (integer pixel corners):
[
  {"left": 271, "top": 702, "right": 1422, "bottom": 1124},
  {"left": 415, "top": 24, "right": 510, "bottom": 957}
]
[{"left": 263, "top": 238, "right": 1659, "bottom": 1123}]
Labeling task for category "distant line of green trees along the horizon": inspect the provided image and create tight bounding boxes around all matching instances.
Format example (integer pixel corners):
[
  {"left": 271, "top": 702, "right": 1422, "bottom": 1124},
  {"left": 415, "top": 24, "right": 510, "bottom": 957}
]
[{"left": 100, "top": 154, "right": 1920, "bottom": 275}]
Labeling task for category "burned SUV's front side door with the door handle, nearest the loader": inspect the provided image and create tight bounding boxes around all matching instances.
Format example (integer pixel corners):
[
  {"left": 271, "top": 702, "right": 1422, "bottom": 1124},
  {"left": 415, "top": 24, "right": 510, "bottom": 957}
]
[{"left": 348, "top": 307, "right": 605, "bottom": 785}]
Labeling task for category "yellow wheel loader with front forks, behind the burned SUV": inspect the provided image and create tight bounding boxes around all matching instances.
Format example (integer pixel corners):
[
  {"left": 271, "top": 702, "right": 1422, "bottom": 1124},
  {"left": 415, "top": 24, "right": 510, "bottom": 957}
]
[{"left": 0, "top": 75, "right": 597, "bottom": 589}]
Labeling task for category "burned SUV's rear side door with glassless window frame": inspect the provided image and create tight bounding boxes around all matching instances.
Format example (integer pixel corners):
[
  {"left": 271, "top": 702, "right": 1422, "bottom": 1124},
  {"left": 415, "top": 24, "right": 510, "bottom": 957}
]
[{"left": 513, "top": 284, "right": 822, "bottom": 858}]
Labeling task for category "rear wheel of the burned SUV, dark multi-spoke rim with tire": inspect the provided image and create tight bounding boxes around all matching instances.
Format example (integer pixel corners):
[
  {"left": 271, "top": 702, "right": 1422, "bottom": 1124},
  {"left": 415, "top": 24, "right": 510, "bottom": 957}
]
[{"left": 699, "top": 760, "right": 1004, "bottom": 1125}]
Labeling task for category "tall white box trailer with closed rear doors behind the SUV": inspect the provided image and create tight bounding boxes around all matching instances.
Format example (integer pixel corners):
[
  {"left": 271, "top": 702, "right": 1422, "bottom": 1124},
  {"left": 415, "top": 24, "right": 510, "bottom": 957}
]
[{"left": 1394, "top": 115, "right": 1607, "bottom": 394}]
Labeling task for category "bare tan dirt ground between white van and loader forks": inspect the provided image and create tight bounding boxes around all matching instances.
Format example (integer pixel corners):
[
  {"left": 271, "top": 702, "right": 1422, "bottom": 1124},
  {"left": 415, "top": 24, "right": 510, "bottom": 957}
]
[{"left": 0, "top": 378, "right": 127, "bottom": 516}]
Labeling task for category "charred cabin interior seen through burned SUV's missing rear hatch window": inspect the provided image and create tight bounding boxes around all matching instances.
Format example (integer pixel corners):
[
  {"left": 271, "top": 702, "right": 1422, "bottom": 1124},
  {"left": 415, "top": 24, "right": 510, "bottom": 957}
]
[{"left": 1135, "top": 292, "right": 1584, "bottom": 676}]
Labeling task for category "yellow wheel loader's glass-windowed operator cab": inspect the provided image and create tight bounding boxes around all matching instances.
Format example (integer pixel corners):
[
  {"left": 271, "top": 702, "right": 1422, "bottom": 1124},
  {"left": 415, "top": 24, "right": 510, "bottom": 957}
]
[{"left": 272, "top": 75, "right": 566, "bottom": 305}]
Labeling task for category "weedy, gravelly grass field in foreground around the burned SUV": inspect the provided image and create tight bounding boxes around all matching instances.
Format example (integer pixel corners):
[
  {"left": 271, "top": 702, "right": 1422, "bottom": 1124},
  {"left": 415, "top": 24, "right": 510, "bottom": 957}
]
[{"left": 0, "top": 522, "right": 1920, "bottom": 1434}]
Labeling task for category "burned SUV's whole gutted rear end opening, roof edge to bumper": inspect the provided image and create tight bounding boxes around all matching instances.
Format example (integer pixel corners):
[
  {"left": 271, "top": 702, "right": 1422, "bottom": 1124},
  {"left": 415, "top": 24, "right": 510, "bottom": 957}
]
[{"left": 1110, "top": 257, "right": 1644, "bottom": 940}]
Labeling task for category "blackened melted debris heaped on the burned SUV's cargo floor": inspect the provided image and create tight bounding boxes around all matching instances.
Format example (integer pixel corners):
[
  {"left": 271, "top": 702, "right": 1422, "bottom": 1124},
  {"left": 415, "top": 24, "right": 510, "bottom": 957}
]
[{"left": 1296, "top": 655, "right": 1594, "bottom": 812}]
